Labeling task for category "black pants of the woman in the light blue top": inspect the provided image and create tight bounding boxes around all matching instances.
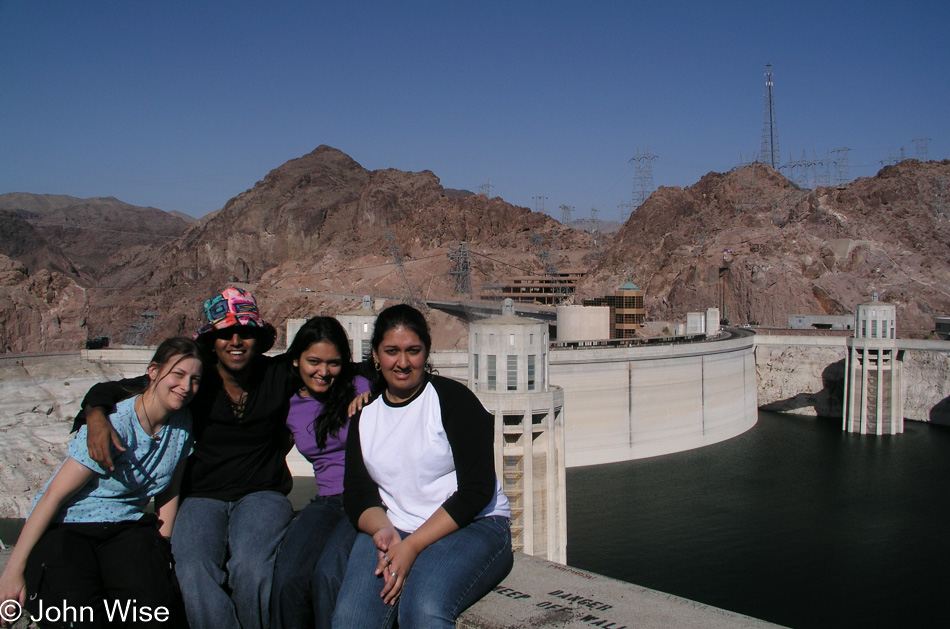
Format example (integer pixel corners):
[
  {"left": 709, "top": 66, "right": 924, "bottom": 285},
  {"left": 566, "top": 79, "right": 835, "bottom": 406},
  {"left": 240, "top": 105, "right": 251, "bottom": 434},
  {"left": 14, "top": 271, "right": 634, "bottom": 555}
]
[{"left": 24, "top": 514, "right": 187, "bottom": 629}]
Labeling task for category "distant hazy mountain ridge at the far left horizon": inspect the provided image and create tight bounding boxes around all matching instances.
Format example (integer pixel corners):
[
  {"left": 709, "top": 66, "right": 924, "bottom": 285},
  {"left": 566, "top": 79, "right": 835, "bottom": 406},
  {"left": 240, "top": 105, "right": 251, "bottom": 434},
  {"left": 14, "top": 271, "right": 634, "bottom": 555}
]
[{"left": 0, "top": 192, "right": 188, "bottom": 278}]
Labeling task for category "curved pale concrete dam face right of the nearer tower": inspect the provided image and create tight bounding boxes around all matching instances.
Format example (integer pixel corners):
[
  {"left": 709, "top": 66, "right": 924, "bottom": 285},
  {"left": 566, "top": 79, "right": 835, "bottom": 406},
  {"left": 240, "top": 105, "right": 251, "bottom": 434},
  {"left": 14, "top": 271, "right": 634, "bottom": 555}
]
[{"left": 550, "top": 334, "right": 758, "bottom": 467}]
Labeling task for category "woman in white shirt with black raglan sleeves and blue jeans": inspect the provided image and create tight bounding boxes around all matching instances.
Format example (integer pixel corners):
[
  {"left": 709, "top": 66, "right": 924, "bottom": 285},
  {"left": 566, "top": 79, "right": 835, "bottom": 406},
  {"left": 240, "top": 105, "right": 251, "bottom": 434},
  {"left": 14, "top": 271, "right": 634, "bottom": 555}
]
[{"left": 333, "top": 305, "right": 512, "bottom": 629}]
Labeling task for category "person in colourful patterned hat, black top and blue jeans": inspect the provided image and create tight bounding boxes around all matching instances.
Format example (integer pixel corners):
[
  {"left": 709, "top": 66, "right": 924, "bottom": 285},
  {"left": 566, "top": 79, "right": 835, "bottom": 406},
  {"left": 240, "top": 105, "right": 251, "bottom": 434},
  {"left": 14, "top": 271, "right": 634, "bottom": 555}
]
[{"left": 75, "top": 287, "right": 294, "bottom": 629}]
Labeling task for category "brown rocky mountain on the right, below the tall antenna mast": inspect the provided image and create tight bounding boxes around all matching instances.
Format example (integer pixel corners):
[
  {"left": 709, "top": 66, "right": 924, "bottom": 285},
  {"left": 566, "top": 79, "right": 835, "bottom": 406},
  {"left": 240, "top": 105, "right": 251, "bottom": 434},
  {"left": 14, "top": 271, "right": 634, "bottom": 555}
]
[{"left": 583, "top": 160, "right": 950, "bottom": 332}]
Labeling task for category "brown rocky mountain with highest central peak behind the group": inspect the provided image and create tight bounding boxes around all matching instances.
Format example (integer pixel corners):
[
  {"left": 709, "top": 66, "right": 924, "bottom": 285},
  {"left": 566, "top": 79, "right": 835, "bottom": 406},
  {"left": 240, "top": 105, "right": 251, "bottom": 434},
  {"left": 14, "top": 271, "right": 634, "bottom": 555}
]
[{"left": 69, "top": 146, "right": 591, "bottom": 346}]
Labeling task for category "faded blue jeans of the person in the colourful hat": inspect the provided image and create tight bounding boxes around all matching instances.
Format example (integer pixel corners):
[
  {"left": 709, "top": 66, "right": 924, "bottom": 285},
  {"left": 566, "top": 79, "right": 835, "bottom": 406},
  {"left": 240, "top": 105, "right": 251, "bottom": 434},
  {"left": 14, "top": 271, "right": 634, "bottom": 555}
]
[{"left": 172, "top": 491, "right": 294, "bottom": 629}]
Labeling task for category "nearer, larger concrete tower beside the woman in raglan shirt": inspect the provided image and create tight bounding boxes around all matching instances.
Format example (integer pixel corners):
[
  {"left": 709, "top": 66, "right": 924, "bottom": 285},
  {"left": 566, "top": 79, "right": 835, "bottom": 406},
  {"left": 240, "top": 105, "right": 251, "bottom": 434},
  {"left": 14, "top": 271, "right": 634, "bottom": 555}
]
[{"left": 468, "top": 299, "right": 567, "bottom": 563}]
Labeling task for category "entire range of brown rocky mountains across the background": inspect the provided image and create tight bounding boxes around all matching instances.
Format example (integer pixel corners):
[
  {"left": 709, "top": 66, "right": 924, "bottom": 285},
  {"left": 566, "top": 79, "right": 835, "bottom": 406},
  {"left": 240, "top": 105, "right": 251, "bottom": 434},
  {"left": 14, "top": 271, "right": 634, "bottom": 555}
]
[{"left": 0, "top": 146, "right": 950, "bottom": 351}]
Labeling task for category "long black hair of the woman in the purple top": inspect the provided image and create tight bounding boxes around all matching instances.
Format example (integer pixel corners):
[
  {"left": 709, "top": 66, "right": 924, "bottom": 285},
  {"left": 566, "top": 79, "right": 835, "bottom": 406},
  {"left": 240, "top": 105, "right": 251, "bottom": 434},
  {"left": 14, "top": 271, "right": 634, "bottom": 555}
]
[{"left": 287, "top": 317, "right": 356, "bottom": 448}]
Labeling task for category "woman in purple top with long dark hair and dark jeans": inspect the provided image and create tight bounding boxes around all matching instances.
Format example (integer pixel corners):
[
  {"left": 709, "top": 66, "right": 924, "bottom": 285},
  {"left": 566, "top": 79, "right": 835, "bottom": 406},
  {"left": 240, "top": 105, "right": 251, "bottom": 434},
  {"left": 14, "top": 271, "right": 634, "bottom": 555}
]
[{"left": 271, "top": 317, "right": 369, "bottom": 629}]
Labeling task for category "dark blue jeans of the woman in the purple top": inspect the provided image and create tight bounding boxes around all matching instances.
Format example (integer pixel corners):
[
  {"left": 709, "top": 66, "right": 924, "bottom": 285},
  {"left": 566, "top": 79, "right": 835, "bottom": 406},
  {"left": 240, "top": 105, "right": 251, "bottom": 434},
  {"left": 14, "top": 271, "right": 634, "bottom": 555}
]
[{"left": 271, "top": 495, "right": 356, "bottom": 629}]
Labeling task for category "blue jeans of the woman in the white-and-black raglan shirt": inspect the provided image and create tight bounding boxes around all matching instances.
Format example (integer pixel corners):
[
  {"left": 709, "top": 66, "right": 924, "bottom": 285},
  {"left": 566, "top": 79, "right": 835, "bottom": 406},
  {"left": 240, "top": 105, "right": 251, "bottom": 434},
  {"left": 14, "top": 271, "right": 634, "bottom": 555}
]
[{"left": 333, "top": 516, "right": 513, "bottom": 629}]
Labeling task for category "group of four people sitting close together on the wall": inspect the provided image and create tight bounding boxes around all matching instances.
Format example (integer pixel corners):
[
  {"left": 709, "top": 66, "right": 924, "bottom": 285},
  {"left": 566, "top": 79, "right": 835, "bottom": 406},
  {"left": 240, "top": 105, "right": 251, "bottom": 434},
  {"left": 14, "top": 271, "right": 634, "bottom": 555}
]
[{"left": 0, "top": 288, "right": 512, "bottom": 629}]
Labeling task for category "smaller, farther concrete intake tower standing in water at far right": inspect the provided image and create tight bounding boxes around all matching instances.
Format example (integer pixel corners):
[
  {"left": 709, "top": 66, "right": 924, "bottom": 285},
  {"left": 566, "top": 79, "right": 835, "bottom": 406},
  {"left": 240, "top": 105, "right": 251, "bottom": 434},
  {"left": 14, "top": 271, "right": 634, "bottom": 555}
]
[{"left": 843, "top": 294, "right": 904, "bottom": 435}]
